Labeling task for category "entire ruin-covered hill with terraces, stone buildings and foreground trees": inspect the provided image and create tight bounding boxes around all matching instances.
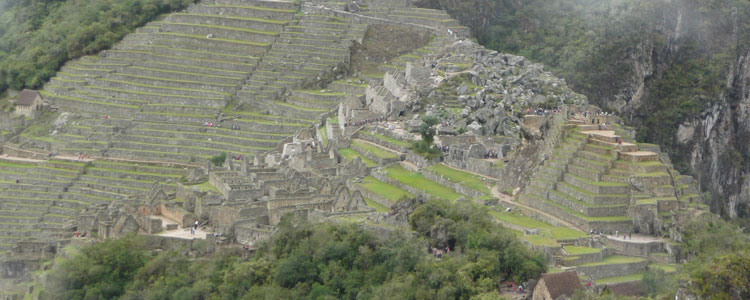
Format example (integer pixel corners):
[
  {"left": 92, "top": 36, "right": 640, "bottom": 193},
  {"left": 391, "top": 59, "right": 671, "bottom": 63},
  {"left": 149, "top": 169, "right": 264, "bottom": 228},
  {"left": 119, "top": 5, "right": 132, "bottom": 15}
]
[{"left": 0, "top": 0, "right": 746, "bottom": 299}]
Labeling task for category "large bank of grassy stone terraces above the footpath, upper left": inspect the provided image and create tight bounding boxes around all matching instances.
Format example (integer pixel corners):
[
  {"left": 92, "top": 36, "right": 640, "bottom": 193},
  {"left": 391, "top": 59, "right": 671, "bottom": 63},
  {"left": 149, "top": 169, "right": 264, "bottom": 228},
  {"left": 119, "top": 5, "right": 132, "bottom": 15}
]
[{"left": 44, "top": 0, "right": 312, "bottom": 162}]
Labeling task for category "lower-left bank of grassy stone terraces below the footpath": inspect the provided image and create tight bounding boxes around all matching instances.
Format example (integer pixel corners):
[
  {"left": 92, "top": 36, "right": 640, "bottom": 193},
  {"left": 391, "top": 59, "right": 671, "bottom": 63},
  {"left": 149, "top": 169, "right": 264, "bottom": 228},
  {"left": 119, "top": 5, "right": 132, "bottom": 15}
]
[{"left": 0, "top": 160, "right": 186, "bottom": 249}]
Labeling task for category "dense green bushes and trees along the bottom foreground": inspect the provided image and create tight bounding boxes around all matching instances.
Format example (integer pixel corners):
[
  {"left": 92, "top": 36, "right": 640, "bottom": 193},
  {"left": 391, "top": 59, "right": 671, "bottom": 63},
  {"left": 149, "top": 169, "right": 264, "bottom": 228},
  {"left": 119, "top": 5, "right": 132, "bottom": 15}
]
[{"left": 41, "top": 201, "right": 545, "bottom": 300}]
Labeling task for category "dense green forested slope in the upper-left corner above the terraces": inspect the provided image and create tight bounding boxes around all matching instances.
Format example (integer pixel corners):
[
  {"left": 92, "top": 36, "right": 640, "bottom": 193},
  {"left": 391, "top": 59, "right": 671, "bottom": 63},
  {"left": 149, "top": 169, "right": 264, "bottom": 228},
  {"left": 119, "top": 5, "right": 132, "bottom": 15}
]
[{"left": 0, "top": 0, "right": 196, "bottom": 95}]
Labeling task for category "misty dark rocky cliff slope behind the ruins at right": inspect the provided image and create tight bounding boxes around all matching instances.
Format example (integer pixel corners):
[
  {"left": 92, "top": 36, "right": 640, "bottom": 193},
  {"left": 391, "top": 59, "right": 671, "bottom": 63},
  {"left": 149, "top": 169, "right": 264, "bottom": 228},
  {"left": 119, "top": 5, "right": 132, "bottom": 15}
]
[{"left": 420, "top": 0, "right": 750, "bottom": 218}]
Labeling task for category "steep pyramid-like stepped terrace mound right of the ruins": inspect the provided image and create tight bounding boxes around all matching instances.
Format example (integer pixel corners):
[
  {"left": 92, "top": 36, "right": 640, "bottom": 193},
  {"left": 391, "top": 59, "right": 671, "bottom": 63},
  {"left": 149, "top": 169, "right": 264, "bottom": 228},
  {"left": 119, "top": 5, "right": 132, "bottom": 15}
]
[{"left": 520, "top": 116, "right": 695, "bottom": 233}]
